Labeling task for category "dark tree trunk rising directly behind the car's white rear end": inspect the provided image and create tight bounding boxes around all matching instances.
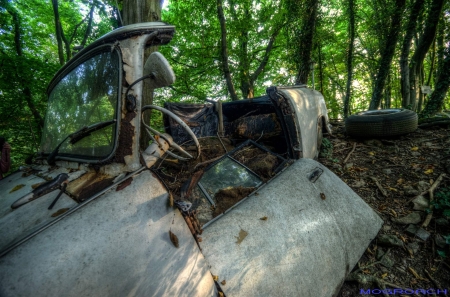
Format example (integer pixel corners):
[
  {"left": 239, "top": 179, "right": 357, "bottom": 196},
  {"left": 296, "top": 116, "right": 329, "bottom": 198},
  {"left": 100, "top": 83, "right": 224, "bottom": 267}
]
[{"left": 295, "top": 0, "right": 320, "bottom": 85}]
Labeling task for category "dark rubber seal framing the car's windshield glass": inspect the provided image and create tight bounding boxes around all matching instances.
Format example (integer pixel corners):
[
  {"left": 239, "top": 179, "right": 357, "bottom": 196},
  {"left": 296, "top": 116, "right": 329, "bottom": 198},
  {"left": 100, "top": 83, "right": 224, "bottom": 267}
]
[{"left": 41, "top": 43, "right": 123, "bottom": 164}]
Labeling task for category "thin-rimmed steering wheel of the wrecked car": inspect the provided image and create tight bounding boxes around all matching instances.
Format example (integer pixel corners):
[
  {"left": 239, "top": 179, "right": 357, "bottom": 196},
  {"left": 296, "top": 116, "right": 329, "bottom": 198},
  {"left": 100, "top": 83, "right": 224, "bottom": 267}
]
[{"left": 141, "top": 105, "right": 201, "bottom": 161}]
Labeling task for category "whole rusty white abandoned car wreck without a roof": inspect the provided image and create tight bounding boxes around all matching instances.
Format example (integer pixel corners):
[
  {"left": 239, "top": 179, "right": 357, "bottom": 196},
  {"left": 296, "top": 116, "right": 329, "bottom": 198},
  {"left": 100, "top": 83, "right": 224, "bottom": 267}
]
[{"left": 0, "top": 22, "right": 382, "bottom": 296}]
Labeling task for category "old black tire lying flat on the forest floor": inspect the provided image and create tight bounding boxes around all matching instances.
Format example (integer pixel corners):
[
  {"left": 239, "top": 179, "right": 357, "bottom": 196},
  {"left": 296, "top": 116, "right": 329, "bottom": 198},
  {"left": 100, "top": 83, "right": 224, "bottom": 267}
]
[{"left": 345, "top": 109, "right": 418, "bottom": 137}]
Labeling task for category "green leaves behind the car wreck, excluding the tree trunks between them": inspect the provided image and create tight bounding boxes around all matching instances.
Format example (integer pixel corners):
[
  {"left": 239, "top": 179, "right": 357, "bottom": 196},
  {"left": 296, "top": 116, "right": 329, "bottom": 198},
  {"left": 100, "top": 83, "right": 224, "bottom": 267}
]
[{"left": 0, "top": 0, "right": 450, "bottom": 176}]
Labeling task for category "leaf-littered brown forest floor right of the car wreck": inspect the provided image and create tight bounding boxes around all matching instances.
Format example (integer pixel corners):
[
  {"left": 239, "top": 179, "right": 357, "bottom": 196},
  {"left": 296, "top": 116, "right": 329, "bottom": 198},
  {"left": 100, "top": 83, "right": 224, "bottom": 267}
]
[{"left": 319, "top": 122, "right": 450, "bottom": 297}]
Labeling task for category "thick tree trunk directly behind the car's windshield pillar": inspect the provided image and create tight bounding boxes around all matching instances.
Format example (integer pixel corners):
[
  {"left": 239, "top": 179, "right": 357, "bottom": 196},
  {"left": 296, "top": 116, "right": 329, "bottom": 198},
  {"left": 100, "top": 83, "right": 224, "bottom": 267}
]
[{"left": 122, "top": 0, "right": 162, "bottom": 150}]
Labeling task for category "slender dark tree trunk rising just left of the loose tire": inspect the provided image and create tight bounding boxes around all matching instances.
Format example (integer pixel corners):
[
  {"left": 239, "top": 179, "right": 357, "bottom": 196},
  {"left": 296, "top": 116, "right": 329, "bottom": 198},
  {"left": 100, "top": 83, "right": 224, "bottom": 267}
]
[{"left": 344, "top": 0, "right": 355, "bottom": 119}]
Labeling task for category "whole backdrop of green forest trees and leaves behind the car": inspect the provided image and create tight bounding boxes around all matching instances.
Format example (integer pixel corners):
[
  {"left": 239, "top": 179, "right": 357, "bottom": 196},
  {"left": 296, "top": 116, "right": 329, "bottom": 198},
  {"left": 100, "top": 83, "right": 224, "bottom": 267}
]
[{"left": 0, "top": 0, "right": 450, "bottom": 166}]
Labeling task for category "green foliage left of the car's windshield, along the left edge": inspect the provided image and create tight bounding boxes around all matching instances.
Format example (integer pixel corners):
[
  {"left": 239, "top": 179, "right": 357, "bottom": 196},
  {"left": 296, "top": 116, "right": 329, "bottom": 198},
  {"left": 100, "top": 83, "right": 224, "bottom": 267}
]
[{"left": 0, "top": 0, "right": 112, "bottom": 171}]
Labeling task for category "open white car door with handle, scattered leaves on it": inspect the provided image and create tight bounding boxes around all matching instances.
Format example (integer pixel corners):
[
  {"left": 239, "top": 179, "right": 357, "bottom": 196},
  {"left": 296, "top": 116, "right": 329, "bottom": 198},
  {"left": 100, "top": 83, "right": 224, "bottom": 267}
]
[{"left": 200, "top": 159, "right": 383, "bottom": 297}]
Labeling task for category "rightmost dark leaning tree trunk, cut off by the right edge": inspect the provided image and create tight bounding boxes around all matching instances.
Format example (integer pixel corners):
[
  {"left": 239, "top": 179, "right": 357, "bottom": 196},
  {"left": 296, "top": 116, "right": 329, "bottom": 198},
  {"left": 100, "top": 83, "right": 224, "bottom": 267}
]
[{"left": 419, "top": 41, "right": 450, "bottom": 118}]
